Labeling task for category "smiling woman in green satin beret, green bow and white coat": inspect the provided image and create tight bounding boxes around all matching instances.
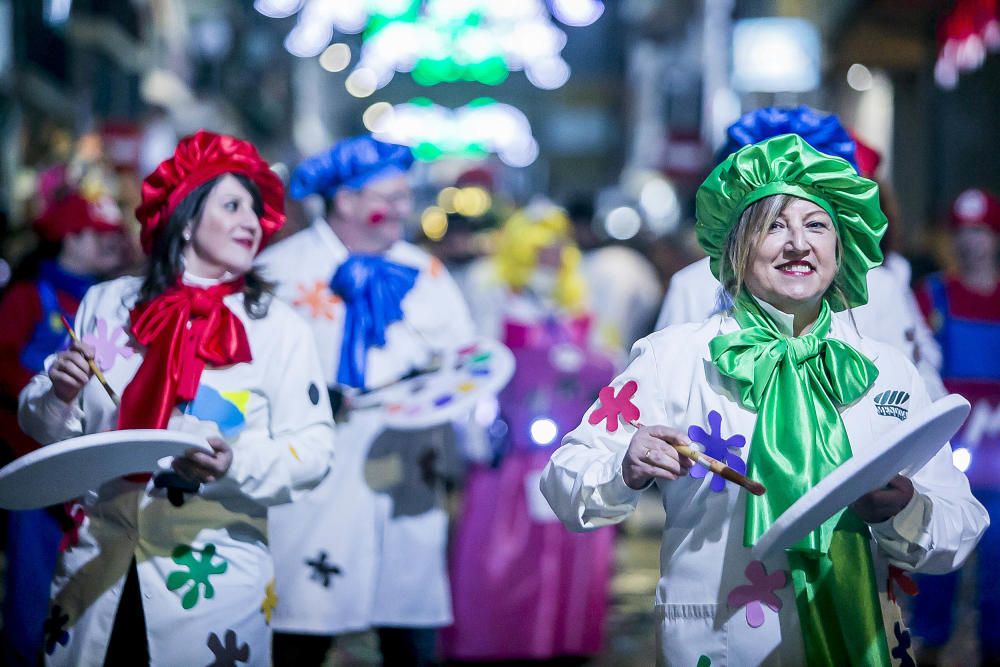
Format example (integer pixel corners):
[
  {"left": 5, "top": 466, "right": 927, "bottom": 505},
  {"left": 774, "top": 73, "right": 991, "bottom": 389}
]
[{"left": 541, "top": 134, "right": 989, "bottom": 667}]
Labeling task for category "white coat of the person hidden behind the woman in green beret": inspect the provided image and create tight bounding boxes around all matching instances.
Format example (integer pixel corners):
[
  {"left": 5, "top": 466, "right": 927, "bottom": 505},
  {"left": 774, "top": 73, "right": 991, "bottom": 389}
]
[{"left": 656, "top": 253, "right": 947, "bottom": 398}]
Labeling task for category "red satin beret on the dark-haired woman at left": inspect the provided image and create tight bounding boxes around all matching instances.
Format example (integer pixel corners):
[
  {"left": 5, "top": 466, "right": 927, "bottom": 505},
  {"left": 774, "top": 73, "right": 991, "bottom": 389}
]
[{"left": 135, "top": 130, "right": 285, "bottom": 254}]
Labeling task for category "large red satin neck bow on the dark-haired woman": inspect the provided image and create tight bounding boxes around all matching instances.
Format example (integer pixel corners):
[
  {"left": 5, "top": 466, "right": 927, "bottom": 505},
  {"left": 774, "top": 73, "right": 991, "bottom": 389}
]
[{"left": 118, "top": 280, "right": 252, "bottom": 429}]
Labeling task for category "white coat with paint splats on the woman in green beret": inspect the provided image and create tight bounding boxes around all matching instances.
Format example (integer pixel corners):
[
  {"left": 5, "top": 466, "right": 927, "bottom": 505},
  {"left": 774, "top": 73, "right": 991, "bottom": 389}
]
[{"left": 541, "top": 311, "right": 989, "bottom": 666}]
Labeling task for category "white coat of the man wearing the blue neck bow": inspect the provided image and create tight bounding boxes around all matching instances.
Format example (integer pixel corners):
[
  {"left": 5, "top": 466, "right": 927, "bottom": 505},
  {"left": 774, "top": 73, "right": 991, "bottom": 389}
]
[{"left": 260, "top": 220, "right": 473, "bottom": 635}]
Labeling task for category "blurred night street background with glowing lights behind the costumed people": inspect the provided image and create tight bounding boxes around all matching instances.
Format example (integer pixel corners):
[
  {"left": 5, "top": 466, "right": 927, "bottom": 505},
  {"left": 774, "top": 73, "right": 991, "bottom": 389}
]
[{"left": 0, "top": 0, "right": 1000, "bottom": 666}]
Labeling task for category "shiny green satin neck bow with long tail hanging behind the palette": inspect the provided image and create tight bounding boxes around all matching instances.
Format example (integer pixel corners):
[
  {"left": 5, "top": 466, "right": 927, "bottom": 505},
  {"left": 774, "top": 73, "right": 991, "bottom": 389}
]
[{"left": 709, "top": 294, "right": 889, "bottom": 665}]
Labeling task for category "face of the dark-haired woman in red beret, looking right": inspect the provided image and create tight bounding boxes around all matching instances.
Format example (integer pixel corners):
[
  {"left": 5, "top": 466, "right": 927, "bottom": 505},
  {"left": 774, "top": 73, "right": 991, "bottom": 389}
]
[{"left": 184, "top": 174, "right": 262, "bottom": 278}]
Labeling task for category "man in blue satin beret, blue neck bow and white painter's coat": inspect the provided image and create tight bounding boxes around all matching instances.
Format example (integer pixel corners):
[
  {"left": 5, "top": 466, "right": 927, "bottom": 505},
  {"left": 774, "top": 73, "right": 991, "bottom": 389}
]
[{"left": 260, "top": 135, "right": 474, "bottom": 665}]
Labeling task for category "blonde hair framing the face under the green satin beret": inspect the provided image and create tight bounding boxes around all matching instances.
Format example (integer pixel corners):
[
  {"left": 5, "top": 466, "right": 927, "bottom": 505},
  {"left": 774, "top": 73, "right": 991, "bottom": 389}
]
[{"left": 719, "top": 194, "right": 848, "bottom": 310}]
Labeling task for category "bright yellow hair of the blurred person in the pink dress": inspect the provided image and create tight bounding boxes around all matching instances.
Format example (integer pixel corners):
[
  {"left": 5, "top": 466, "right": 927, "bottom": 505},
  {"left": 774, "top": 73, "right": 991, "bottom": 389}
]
[{"left": 493, "top": 204, "right": 587, "bottom": 313}]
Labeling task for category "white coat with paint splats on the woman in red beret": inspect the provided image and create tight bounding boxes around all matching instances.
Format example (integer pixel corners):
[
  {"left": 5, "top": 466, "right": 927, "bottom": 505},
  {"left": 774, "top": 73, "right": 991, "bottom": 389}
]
[{"left": 20, "top": 277, "right": 334, "bottom": 667}]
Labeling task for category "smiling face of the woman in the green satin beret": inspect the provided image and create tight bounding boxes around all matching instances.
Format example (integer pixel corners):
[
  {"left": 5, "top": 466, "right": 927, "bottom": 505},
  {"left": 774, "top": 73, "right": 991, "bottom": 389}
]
[{"left": 744, "top": 197, "right": 838, "bottom": 315}]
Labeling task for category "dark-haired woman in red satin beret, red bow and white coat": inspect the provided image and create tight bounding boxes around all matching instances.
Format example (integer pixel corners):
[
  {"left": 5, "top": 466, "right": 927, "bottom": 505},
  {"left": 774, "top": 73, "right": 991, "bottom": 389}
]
[{"left": 20, "top": 131, "right": 333, "bottom": 665}]
